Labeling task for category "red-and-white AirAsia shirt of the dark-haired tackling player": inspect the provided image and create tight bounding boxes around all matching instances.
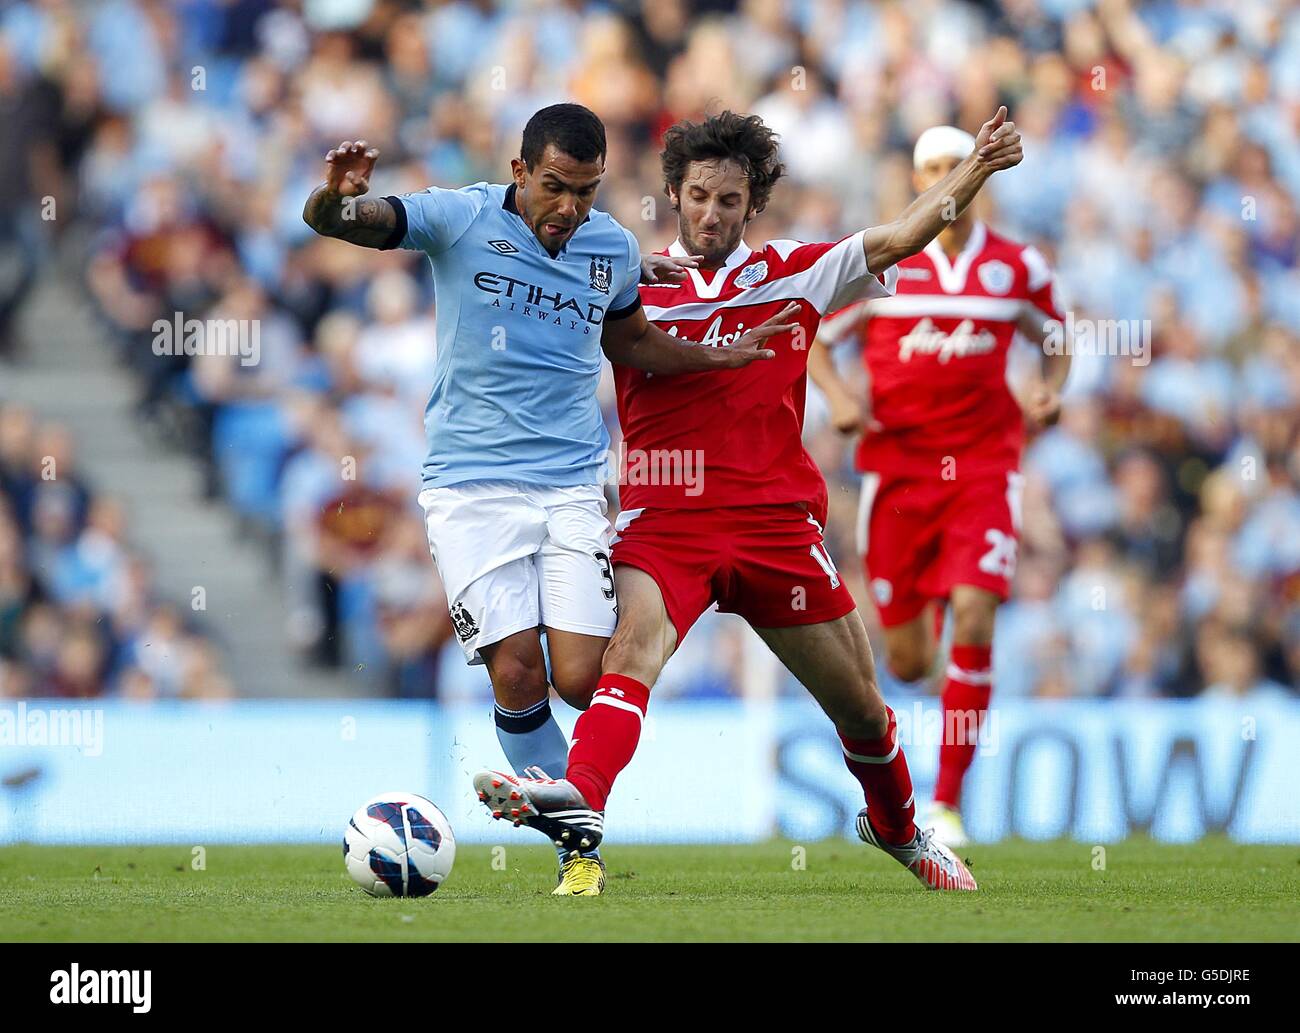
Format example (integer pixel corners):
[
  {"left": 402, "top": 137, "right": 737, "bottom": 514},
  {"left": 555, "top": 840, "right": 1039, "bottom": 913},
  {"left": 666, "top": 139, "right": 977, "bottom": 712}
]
[{"left": 614, "top": 233, "right": 894, "bottom": 520}]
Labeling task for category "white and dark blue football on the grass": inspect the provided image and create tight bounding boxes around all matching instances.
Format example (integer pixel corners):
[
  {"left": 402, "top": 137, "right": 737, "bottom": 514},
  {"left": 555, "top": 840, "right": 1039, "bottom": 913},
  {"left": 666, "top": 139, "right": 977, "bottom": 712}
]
[{"left": 343, "top": 793, "right": 456, "bottom": 897}]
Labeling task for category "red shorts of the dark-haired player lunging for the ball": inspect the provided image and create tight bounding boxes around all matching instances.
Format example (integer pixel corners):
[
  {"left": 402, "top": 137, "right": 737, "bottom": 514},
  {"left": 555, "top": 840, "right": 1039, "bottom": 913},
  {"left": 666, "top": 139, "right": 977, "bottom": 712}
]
[{"left": 612, "top": 503, "right": 857, "bottom": 643}]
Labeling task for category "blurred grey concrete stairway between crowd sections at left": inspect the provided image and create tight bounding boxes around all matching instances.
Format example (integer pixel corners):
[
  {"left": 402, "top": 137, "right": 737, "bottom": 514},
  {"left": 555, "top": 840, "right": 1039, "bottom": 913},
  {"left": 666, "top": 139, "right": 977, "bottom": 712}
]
[{"left": 0, "top": 269, "right": 380, "bottom": 698}]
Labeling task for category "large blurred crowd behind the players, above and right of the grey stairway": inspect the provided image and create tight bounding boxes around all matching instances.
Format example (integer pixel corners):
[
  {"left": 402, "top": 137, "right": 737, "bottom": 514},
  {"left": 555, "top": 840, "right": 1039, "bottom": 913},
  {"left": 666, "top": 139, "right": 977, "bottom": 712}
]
[{"left": 0, "top": 0, "right": 1300, "bottom": 698}]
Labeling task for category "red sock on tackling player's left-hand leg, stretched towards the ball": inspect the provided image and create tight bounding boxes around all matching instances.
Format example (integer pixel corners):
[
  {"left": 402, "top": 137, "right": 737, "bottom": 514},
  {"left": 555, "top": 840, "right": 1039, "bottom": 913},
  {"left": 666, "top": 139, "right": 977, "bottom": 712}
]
[{"left": 564, "top": 674, "right": 650, "bottom": 811}]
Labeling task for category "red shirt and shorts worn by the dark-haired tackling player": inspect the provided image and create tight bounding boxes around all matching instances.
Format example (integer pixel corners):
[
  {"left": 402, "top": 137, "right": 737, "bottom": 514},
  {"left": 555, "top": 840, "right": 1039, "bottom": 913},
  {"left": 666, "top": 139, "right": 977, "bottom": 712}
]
[{"left": 612, "top": 233, "right": 894, "bottom": 642}]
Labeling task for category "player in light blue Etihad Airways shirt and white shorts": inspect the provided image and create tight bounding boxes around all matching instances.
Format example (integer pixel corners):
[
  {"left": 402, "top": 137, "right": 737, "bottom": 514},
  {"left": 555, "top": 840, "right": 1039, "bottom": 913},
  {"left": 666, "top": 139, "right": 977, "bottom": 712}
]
[{"left": 303, "top": 104, "right": 796, "bottom": 895}]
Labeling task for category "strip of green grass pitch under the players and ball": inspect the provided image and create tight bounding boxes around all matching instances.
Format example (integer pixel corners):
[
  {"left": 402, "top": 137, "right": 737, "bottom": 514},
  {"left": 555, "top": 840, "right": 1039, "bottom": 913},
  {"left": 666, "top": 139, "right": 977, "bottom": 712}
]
[{"left": 0, "top": 839, "right": 1300, "bottom": 942}]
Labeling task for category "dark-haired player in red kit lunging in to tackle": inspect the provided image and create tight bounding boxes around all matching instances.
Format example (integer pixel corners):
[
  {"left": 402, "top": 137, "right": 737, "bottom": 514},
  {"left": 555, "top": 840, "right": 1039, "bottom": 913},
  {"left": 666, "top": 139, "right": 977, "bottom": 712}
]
[{"left": 476, "top": 108, "right": 1021, "bottom": 890}]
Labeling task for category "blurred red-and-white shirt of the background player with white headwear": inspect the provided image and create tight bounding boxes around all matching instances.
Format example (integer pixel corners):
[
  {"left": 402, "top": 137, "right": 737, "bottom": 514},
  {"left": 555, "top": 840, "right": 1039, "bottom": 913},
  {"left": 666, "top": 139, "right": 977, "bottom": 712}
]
[{"left": 822, "top": 222, "right": 1065, "bottom": 474}]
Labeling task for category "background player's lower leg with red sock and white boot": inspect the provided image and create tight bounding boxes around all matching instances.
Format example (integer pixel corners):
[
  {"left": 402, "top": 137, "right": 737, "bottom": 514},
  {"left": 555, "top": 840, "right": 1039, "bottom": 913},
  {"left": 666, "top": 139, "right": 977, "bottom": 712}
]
[{"left": 930, "top": 585, "right": 1001, "bottom": 847}]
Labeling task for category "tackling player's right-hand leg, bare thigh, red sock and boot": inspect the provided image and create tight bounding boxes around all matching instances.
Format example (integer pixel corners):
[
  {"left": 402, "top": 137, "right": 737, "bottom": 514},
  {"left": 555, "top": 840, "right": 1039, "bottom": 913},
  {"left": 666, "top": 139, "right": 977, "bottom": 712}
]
[{"left": 754, "top": 609, "right": 975, "bottom": 890}]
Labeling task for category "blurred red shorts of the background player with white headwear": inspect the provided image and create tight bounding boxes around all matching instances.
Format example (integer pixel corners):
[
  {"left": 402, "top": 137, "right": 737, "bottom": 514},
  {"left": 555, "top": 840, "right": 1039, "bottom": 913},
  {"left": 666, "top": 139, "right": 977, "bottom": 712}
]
[{"left": 858, "top": 470, "right": 1024, "bottom": 628}]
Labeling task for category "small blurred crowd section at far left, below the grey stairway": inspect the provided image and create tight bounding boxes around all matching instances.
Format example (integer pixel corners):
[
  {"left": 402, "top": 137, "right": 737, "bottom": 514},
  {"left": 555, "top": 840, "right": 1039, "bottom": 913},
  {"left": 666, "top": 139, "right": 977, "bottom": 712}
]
[{"left": 0, "top": 405, "right": 233, "bottom": 699}]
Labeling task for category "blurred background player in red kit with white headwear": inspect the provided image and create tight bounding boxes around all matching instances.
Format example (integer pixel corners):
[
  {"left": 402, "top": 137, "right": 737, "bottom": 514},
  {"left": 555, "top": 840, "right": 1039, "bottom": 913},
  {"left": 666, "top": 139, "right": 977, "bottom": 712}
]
[{"left": 809, "top": 126, "right": 1070, "bottom": 847}]
